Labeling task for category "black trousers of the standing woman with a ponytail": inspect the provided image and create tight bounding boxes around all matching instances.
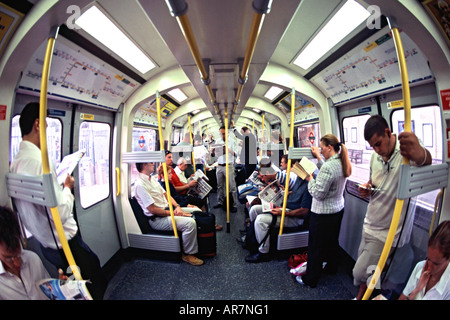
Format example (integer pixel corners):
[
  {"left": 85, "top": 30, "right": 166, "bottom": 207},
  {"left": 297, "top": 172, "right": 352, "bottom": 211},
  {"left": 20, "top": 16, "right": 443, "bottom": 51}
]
[{"left": 302, "top": 209, "right": 344, "bottom": 287}]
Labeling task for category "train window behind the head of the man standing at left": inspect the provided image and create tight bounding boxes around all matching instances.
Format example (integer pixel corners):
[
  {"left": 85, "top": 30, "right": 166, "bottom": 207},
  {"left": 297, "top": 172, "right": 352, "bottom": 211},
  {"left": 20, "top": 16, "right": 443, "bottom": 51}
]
[{"left": 9, "top": 115, "right": 62, "bottom": 166}]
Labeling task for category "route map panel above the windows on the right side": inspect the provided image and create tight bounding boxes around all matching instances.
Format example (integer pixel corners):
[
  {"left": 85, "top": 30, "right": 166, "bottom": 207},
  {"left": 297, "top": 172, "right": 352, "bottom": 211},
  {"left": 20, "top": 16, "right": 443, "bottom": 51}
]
[{"left": 311, "top": 29, "right": 432, "bottom": 104}]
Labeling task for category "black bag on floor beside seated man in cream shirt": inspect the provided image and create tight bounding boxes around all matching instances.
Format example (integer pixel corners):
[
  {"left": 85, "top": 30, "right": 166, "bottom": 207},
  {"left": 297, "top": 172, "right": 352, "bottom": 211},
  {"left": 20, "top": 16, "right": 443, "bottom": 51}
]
[{"left": 193, "top": 211, "right": 217, "bottom": 257}]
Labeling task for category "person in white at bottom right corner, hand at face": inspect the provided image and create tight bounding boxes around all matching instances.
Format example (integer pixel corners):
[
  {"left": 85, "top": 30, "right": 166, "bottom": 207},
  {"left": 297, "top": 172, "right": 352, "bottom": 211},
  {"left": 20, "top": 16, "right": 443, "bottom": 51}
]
[{"left": 399, "top": 220, "right": 450, "bottom": 300}]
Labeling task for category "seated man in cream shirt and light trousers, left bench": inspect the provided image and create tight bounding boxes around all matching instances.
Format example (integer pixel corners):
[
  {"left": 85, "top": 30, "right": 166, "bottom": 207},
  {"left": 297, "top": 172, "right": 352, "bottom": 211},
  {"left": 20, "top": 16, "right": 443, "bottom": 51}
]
[{"left": 135, "top": 163, "right": 203, "bottom": 266}]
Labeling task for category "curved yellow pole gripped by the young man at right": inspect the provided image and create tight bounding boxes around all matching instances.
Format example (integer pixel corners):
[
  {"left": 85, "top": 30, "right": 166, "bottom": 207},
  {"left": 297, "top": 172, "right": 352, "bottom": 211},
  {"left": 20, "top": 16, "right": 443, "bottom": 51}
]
[{"left": 362, "top": 27, "right": 411, "bottom": 300}]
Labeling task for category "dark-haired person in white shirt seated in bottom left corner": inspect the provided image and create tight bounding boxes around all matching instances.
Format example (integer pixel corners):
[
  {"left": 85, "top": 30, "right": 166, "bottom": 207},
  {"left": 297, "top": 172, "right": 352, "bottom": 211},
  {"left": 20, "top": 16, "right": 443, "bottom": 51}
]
[{"left": 0, "top": 207, "right": 50, "bottom": 300}]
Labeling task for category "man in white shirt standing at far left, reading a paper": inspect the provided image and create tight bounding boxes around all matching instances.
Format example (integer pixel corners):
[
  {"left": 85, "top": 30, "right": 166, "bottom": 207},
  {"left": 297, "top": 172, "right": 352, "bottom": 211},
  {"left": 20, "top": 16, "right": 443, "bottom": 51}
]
[{"left": 10, "top": 103, "right": 107, "bottom": 300}]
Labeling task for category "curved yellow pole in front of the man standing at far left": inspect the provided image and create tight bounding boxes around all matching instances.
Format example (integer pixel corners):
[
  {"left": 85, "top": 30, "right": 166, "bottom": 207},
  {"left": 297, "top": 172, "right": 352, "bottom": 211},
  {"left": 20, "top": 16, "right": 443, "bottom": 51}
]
[{"left": 39, "top": 27, "right": 83, "bottom": 280}]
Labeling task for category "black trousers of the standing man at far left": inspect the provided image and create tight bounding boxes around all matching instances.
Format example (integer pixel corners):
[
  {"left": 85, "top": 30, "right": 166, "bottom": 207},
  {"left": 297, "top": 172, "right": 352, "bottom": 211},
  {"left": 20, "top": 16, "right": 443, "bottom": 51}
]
[{"left": 41, "top": 232, "right": 108, "bottom": 300}]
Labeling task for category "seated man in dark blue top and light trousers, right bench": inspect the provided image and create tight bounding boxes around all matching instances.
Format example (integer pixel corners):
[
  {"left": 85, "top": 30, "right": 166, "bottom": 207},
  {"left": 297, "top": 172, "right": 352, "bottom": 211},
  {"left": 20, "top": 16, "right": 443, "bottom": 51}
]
[{"left": 245, "top": 159, "right": 312, "bottom": 263}]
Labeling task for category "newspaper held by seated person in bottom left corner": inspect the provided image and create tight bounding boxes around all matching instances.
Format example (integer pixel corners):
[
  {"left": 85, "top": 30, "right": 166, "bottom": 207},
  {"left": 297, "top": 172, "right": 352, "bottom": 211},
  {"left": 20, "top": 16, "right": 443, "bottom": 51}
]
[{"left": 36, "top": 279, "right": 92, "bottom": 300}]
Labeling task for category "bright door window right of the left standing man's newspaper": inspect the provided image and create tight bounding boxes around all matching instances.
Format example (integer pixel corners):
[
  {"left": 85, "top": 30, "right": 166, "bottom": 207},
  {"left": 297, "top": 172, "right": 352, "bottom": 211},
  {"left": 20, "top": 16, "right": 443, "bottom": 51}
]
[{"left": 78, "top": 122, "right": 111, "bottom": 208}]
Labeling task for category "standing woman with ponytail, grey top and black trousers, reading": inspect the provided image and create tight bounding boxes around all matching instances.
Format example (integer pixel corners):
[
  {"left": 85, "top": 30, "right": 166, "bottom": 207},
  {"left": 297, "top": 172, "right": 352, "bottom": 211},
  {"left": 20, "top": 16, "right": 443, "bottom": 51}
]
[{"left": 297, "top": 134, "right": 352, "bottom": 288}]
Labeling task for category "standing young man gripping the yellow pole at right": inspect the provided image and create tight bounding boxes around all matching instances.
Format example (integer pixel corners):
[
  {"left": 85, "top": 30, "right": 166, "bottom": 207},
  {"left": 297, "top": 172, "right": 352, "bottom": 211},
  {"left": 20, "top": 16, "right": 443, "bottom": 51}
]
[{"left": 353, "top": 115, "right": 431, "bottom": 299}]
